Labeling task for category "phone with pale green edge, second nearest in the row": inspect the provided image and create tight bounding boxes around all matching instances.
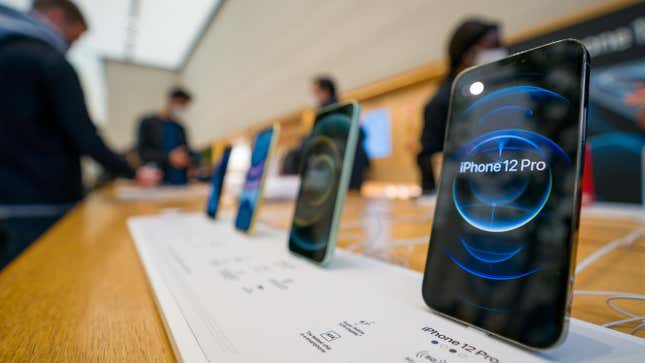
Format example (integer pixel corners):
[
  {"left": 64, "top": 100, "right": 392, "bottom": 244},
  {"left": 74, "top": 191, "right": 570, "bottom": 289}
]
[{"left": 289, "top": 102, "right": 360, "bottom": 265}]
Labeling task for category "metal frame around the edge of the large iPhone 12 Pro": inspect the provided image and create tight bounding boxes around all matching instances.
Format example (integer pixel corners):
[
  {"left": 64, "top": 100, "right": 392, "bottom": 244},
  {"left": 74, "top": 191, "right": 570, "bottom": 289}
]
[{"left": 421, "top": 39, "right": 591, "bottom": 351}]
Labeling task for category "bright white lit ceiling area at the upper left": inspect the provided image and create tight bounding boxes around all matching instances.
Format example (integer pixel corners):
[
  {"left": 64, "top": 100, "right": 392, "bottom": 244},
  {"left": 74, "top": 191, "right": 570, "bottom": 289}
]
[{"left": 0, "top": 0, "right": 220, "bottom": 124}]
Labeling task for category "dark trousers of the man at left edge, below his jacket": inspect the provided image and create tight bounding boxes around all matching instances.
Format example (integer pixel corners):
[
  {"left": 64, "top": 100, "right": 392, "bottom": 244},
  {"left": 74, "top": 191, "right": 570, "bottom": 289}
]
[{"left": 0, "top": 215, "right": 62, "bottom": 270}]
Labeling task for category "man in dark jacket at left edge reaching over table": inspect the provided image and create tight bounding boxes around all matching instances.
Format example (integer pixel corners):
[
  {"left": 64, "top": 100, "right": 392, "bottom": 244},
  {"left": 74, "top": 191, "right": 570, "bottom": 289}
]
[{"left": 0, "top": 0, "right": 160, "bottom": 269}]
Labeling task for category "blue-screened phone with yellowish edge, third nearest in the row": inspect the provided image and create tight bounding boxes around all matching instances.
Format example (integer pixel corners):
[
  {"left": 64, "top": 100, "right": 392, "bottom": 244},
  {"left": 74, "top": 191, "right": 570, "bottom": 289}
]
[{"left": 235, "top": 125, "right": 280, "bottom": 234}]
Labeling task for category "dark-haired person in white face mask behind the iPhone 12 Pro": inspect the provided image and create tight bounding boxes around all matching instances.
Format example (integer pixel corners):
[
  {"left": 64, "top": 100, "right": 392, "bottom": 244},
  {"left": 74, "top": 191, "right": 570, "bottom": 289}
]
[{"left": 417, "top": 19, "right": 506, "bottom": 194}]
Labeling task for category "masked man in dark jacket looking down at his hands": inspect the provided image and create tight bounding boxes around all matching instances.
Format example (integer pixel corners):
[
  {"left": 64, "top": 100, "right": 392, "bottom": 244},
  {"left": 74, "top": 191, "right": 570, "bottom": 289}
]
[{"left": 137, "top": 88, "right": 198, "bottom": 185}]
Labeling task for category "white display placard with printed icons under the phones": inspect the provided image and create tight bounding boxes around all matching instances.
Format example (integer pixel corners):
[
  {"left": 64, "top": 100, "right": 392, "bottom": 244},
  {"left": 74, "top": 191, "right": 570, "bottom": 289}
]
[{"left": 129, "top": 214, "right": 645, "bottom": 363}]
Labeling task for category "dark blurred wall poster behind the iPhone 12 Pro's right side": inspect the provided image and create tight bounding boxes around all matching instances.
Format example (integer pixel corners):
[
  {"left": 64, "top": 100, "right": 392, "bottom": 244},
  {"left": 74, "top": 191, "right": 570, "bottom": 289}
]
[{"left": 509, "top": 2, "right": 645, "bottom": 203}]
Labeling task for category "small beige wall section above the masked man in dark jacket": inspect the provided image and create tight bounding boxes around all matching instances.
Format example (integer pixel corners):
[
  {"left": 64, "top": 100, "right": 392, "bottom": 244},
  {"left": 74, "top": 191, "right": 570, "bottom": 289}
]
[{"left": 103, "top": 60, "right": 177, "bottom": 150}]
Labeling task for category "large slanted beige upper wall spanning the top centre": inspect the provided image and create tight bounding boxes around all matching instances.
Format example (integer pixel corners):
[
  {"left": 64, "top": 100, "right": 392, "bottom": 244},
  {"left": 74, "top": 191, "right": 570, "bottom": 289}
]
[{"left": 181, "top": 0, "right": 603, "bottom": 144}]
